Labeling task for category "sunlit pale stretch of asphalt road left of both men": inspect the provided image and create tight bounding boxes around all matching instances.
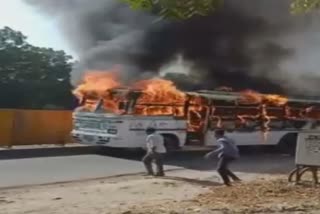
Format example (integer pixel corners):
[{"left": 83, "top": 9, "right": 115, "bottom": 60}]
[{"left": 0, "top": 149, "right": 182, "bottom": 187}]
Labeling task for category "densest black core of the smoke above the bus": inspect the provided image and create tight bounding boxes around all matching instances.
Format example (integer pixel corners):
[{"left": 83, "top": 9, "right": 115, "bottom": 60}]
[{"left": 136, "top": 9, "right": 293, "bottom": 92}]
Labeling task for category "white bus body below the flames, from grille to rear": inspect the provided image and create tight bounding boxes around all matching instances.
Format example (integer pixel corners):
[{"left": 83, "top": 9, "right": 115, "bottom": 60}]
[{"left": 72, "top": 91, "right": 320, "bottom": 153}]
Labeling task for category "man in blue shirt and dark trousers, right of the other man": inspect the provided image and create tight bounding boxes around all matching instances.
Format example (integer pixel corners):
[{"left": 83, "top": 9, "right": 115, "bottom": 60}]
[{"left": 205, "top": 129, "right": 240, "bottom": 186}]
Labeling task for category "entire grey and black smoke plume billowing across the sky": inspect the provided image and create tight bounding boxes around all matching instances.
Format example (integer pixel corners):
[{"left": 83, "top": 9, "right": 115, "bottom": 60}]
[{"left": 25, "top": 0, "right": 320, "bottom": 95}]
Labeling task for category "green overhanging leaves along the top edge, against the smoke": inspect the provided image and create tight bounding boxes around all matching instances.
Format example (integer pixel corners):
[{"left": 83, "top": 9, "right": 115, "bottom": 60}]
[{"left": 120, "top": 0, "right": 320, "bottom": 19}]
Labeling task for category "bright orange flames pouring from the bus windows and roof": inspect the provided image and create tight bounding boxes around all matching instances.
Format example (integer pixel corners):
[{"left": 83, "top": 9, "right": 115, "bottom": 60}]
[{"left": 73, "top": 70, "right": 320, "bottom": 142}]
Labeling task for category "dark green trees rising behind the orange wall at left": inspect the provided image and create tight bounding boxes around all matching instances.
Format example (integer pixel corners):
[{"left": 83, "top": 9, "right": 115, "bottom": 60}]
[{"left": 0, "top": 27, "right": 73, "bottom": 109}]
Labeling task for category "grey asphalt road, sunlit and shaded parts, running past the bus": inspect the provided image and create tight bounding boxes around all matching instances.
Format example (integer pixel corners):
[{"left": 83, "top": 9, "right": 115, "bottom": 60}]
[{"left": 0, "top": 148, "right": 293, "bottom": 187}]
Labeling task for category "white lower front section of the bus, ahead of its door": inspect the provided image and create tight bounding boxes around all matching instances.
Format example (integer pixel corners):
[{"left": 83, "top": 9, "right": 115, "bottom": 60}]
[{"left": 72, "top": 112, "right": 187, "bottom": 148}]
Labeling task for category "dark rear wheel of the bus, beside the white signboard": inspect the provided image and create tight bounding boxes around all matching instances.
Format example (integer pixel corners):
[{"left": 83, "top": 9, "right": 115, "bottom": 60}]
[{"left": 278, "top": 133, "right": 298, "bottom": 156}]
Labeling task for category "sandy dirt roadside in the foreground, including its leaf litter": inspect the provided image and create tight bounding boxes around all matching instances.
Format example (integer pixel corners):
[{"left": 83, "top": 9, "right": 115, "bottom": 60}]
[{"left": 0, "top": 169, "right": 320, "bottom": 214}]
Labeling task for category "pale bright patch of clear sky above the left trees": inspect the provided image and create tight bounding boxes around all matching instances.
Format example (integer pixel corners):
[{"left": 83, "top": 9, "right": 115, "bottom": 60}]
[{"left": 0, "top": 0, "right": 73, "bottom": 54}]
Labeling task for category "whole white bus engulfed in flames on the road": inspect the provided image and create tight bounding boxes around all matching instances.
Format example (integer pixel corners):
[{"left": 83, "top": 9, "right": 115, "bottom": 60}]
[{"left": 72, "top": 73, "right": 320, "bottom": 152}]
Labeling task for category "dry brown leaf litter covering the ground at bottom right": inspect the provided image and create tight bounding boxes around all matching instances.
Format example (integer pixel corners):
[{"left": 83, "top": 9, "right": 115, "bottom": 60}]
[{"left": 131, "top": 178, "right": 320, "bottom": 214}]
